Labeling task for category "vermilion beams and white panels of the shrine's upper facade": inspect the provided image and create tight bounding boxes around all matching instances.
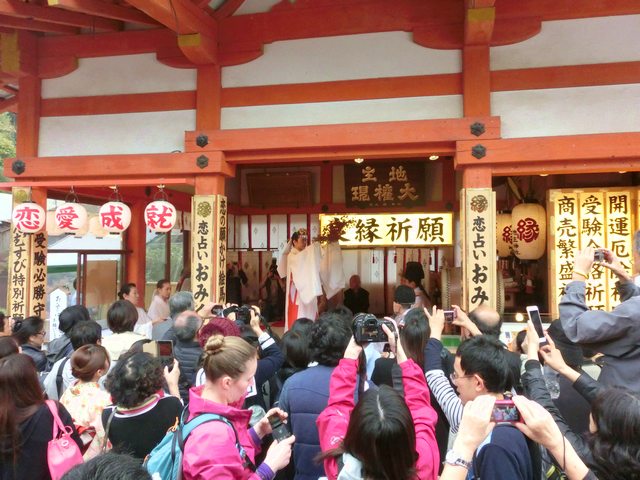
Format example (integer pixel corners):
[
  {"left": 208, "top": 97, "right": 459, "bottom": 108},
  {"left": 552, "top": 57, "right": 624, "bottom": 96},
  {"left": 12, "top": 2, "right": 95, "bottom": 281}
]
[{"left": 0, "top": 0, "right": 640, "bottom": 320}]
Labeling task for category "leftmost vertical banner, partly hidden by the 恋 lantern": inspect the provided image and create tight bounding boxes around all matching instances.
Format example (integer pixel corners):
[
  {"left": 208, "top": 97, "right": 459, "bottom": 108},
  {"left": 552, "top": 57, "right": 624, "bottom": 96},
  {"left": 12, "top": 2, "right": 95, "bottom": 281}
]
[{"left": 7, "top": 188, "right": 31, "bottom": 318}]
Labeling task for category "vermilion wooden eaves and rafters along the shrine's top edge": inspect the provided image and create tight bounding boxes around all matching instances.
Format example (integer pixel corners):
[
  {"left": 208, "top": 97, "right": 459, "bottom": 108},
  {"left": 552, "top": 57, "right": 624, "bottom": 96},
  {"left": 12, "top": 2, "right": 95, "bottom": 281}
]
[{"left": 0, "top": 0, "right": 640, "bottom": 111}]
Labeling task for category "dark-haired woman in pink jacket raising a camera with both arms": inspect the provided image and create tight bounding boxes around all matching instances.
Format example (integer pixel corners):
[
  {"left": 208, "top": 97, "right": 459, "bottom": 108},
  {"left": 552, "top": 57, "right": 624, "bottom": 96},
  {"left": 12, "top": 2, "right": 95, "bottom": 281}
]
[{"left": 317, "top": 327, "right": 440, "bottom": 480}]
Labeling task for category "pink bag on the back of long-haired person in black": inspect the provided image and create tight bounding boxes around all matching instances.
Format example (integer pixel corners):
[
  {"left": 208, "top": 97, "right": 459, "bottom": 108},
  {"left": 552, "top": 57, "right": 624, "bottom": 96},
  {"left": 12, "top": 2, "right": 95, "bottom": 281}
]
[{"left": 46, "top": 400, "right": 83, "bottom": 480}]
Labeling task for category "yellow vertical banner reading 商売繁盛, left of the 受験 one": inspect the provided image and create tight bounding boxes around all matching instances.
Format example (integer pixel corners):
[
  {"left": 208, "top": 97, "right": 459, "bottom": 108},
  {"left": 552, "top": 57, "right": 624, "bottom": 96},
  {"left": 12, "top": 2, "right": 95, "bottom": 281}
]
[{"left": 547, "top": 190, "right": 580, "bottom": 318}]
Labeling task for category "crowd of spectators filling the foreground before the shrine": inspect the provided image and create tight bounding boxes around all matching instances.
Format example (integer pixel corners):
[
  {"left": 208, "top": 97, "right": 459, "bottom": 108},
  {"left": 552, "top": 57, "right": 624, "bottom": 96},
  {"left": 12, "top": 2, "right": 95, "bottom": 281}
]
[{"left": 0, "top": 242, "right": 640, "bottom": 480}]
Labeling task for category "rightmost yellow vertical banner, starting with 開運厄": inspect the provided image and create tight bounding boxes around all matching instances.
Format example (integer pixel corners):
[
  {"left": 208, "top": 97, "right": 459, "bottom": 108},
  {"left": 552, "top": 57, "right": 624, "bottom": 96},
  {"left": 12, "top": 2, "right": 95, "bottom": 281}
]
[{"left": 605, "top": 191, "right": 634, "bottom": 308}]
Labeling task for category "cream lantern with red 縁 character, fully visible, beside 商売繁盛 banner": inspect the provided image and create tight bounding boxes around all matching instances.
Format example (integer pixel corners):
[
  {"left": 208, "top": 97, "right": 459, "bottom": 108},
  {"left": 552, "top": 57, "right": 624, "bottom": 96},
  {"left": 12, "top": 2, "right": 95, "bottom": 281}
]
[{"left": 511, "top": 203, "right": 547, "bottom": 260}]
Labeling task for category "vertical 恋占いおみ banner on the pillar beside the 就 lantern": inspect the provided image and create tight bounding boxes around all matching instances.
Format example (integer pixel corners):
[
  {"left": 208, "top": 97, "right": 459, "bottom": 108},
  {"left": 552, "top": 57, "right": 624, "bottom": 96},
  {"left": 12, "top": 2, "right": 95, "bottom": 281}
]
[{"left": 191, "top": 195, "right": 216, "bottom": 310}]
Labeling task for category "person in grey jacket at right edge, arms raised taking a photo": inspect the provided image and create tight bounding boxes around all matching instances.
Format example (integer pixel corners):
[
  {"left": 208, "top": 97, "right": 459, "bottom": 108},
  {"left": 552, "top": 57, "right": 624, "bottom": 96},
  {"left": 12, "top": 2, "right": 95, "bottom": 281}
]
[{"left": 559, "top": 247, "right": 640, "bottom": 393}]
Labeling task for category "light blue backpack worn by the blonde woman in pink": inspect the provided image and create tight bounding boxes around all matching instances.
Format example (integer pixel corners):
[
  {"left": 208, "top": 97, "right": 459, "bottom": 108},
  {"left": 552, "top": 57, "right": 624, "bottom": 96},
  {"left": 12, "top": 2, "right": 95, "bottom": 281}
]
[{"left": 143, "top": 405, "right": 256, "bottom": 480}]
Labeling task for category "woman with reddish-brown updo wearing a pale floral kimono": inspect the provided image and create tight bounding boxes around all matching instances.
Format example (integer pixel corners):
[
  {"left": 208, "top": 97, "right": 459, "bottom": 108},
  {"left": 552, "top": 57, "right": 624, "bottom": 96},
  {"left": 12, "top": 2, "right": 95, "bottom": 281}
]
[{"left": 60, "top": 345, "right": 111, "bottom": 460}]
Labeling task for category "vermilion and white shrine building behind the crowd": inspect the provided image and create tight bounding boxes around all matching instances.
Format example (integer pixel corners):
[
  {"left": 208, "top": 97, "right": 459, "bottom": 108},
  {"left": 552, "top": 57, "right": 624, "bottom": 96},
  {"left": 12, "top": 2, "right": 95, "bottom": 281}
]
[{"left": 0, "top": 0, "right": 640, "bottom": 324}]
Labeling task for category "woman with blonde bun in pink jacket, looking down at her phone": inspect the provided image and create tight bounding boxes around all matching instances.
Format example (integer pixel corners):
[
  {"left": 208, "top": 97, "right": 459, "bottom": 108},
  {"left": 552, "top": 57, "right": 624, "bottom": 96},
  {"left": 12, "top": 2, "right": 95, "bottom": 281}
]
[{"left": 182, "top": 335, "right": 295, "bottom": 480}]
